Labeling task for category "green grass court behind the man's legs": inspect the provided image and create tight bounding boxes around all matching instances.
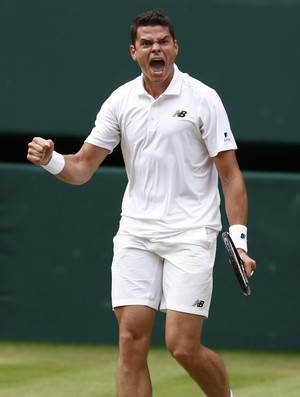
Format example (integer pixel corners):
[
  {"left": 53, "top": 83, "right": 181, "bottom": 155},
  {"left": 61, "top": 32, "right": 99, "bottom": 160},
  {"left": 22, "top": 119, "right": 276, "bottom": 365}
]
[{"left": 0, "top": 342, "right": 300, "bottom": 397}]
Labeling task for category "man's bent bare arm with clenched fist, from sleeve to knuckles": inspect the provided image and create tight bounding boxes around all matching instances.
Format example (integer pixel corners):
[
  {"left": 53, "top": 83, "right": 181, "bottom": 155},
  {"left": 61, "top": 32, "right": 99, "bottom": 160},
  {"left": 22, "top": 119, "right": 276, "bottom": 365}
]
[{"left": 27, "top": 137, "right": 109, "bottom": 185}]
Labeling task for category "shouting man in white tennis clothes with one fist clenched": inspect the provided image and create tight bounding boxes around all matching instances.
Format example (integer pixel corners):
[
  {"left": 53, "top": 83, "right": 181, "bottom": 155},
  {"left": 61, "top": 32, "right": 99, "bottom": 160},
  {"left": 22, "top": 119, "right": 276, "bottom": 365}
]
[{"left": 28, "top": 10, "right": 256, "bottom": 397}]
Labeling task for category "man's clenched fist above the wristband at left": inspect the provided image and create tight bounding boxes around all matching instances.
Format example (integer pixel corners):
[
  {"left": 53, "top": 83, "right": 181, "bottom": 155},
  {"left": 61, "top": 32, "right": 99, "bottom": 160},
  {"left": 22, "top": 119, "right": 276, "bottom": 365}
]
[{"left": 27, "top": 138, "right": 54, "bottom": 165}]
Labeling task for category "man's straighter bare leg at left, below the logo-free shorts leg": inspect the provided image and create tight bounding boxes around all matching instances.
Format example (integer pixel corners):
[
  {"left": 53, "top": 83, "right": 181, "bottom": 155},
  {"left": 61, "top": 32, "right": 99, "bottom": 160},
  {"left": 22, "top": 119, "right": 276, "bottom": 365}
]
[{"left": 115, "top": 306, "right": 156, "bottom": 397}]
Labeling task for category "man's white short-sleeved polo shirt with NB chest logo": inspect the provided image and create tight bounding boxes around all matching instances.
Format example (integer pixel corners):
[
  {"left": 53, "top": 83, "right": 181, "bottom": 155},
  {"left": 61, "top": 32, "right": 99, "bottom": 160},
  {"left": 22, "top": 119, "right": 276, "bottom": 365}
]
[{"left": 86, "top": 65, "right": 237, "bottom": 237}]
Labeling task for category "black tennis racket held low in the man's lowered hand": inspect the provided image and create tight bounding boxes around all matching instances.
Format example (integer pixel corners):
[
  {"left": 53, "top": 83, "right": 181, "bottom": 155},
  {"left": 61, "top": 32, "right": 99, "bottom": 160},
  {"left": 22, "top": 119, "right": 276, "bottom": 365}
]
[{"left": 222, "top": 232, "right": 251, "bottom": 296}]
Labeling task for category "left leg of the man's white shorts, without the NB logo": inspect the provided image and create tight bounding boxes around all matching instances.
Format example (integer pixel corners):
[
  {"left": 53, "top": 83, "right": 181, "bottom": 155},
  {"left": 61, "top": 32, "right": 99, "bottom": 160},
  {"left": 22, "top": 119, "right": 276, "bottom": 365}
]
[{"left": 112, "top": 235, "right": 163, "bottom": 310}]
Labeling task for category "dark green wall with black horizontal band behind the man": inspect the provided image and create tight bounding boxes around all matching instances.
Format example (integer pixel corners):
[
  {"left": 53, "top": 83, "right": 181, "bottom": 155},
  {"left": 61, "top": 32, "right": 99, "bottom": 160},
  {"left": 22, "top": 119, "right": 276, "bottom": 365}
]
[{"left": 0, "top": 0, "right": 300, "bottom": 350}]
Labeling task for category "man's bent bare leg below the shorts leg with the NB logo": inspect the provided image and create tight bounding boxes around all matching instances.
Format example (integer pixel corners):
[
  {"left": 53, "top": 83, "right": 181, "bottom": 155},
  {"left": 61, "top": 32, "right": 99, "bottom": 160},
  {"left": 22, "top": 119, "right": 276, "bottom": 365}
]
[{"left": 166, "top": 310, "right": 230, "bottom": 397}]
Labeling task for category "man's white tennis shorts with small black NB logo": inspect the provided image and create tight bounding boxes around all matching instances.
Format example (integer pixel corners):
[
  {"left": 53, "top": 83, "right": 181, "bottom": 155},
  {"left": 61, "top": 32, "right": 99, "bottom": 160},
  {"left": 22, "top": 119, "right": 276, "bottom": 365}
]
[{"left": 112, "top": 228, "right": 218, "bottom": 317}]
